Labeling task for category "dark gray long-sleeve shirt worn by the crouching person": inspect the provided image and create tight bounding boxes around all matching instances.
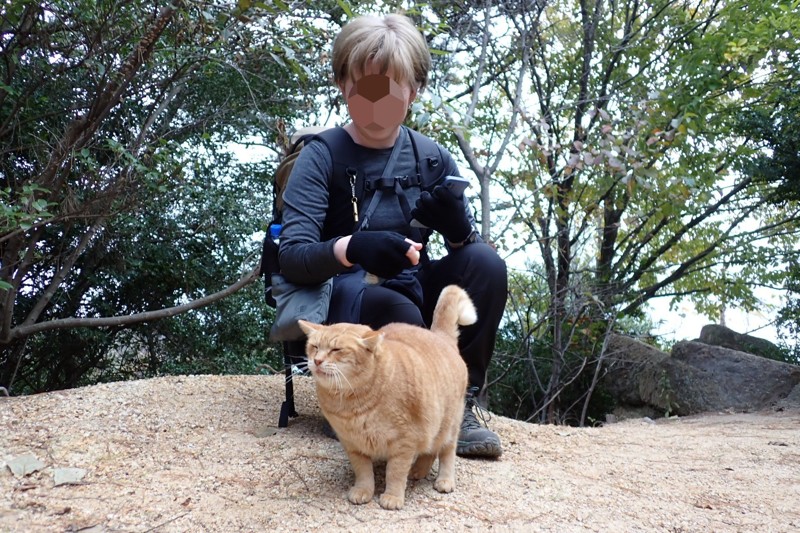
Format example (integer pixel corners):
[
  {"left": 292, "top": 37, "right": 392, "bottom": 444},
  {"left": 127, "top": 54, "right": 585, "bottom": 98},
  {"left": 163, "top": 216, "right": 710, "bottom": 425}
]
[{"left": 280, "top": 128, "right": 474, "bottom": 283}]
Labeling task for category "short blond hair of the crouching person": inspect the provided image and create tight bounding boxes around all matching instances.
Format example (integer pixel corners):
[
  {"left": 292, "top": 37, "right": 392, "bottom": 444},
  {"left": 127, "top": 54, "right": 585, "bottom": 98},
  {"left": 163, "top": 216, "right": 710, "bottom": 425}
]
[{"left": 333, "top": 14, "right": 431, "bottom": 90}]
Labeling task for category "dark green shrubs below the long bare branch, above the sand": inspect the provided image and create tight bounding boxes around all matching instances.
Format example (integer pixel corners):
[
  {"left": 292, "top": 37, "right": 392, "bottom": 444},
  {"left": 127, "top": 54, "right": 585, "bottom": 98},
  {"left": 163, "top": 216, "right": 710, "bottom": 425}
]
[{"left": 14, "top": 283, "right": 283, "bottom": 394}]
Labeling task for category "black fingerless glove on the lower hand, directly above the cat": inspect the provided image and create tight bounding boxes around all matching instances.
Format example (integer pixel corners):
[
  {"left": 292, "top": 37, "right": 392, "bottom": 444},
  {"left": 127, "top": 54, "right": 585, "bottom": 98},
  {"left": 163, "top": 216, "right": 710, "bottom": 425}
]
[{"left": 345, "top": 231, "right": 411, "bottom": 279}]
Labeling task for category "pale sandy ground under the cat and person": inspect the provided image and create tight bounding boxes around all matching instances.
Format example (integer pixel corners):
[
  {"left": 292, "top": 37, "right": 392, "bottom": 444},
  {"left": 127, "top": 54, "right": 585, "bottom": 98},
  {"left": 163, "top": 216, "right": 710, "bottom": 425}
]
[{"left": 0, "top": 376, "right": 800, "bottom": 533}]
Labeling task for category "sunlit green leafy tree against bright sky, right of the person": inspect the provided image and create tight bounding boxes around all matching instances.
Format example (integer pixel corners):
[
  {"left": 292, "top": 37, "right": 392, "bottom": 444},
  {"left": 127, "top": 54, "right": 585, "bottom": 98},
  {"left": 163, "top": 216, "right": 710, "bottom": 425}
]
[{"left": 418, "top": 1, "right": 800, "bottom": 421}]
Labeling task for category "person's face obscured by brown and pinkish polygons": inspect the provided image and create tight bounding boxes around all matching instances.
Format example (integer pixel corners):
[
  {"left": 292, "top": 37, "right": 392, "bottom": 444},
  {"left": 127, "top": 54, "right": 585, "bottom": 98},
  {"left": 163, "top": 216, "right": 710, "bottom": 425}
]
[{"left": 339, "top": 68, "right": 417, "bottom": 145}]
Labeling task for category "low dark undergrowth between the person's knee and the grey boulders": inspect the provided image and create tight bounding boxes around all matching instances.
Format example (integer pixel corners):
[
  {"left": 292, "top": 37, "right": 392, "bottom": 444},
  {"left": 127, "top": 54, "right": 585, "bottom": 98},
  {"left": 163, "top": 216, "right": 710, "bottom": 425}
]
[{"left": 488, "top": 269, "right": 616, "bottom": 425}]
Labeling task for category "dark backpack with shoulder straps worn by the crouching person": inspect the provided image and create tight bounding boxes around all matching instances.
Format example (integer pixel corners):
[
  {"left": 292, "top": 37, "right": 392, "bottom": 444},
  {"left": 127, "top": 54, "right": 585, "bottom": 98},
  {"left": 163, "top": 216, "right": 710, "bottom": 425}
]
[{"left": 261, "top": 127, "right": 447, "bottom": 308}]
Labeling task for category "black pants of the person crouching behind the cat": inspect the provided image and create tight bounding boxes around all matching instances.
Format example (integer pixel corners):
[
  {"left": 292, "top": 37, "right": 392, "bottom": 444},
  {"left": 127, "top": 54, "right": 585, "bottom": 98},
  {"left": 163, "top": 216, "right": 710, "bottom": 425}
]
[{"left": 340, "top": 243, "right": 508, "bottom": 389}]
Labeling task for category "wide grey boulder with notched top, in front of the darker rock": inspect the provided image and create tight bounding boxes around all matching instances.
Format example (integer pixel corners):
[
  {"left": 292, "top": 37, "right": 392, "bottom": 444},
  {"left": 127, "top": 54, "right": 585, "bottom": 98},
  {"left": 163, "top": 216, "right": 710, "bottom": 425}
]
[{"left": 603, "top": 335, "right": 800, "bottom": 416}]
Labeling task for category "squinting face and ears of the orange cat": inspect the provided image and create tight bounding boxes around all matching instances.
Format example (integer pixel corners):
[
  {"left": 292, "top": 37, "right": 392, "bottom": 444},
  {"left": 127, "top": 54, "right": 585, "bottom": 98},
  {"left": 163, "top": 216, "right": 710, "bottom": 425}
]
[{"left": 299, "top": 320, "right": 380, "bottom": 390}]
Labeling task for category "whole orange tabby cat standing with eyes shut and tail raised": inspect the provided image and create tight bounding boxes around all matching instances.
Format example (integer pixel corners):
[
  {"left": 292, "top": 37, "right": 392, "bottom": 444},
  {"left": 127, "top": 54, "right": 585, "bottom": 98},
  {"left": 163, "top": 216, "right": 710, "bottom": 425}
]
[{"left": 299, "top": 285, "right": 477, "bottom": 509}]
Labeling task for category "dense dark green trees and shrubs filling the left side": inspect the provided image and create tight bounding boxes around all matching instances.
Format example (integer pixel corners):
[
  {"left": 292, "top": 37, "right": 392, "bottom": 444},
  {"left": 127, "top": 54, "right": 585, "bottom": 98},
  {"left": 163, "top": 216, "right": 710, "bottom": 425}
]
[{"left": 0, "top": 0, "right": 334, "bottom": 392}]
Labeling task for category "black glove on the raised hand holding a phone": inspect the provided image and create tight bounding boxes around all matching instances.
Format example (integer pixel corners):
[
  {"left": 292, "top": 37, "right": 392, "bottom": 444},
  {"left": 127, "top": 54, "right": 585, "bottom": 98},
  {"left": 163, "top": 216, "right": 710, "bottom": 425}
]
[{"left": 411, "top": 185, "right": 472, "bottom": 243}]
